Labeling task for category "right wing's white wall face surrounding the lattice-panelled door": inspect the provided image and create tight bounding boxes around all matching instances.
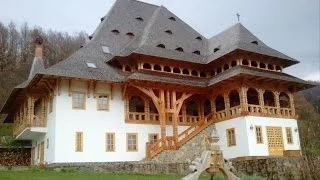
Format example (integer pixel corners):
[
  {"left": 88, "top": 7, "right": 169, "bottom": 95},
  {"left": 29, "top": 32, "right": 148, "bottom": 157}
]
[{"left": 246, "top": 116, "right": 300, "bottom": 156}]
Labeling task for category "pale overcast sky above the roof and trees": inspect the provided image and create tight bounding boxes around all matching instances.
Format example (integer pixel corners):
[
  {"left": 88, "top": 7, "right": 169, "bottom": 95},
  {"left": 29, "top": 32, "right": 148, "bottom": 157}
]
[{"left": 0, "top": 0, "right": 320, "bottom": 81}]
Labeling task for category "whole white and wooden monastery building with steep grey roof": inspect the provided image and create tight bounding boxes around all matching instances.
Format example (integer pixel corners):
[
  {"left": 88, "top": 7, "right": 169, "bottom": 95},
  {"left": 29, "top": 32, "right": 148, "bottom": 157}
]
[{"left": 1, "top": 0, "right": 313, "bottom": 164}]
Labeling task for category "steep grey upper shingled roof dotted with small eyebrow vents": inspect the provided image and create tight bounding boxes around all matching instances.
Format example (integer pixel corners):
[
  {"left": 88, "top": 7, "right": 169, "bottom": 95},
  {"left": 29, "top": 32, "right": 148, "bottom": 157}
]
[{"left": 37, "top": 0, "right": 297, "bottom": 82}]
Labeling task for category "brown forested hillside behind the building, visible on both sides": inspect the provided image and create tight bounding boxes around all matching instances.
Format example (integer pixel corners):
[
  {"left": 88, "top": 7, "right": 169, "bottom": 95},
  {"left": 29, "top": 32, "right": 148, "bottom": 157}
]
[{"left": 0, "top": 22, "right": 320, "bottom": 155}]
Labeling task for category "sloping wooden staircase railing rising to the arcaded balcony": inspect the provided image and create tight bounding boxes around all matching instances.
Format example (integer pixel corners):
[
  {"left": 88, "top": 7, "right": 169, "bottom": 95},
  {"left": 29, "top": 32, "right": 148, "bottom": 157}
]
[{"left": 146, "top": 113, "right": 215, "bottom": 160}]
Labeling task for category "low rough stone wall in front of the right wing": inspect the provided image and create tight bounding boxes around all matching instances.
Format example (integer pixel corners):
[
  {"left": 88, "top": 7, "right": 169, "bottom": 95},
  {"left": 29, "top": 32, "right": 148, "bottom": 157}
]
[{"left": 231, "top": 157, "right": 320, "bottom": 180}]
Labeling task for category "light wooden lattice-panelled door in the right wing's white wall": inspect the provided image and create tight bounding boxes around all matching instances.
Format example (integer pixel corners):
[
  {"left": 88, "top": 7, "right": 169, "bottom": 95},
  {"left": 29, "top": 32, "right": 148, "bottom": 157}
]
[{"left": 267, "top": 127, "right": 283, "bottom": 156}]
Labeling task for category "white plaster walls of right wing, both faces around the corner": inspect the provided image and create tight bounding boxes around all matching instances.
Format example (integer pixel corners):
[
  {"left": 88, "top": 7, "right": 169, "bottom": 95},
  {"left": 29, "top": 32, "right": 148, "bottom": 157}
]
[{"left": 216, "top": 116, "right": 300, "bottom": 158}]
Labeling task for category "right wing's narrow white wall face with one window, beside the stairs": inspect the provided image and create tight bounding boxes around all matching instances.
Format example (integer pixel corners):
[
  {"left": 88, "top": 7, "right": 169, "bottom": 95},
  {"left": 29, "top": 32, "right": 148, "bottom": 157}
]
[{"left": 215, "top": 117, "right": 249, "bottom": 159}]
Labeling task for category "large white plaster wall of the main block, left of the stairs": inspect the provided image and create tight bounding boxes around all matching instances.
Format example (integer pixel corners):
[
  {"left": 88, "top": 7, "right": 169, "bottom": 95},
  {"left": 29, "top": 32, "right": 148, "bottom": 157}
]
[{"left": 49, "top": 81, "right": 187, "bottom": 163}]
